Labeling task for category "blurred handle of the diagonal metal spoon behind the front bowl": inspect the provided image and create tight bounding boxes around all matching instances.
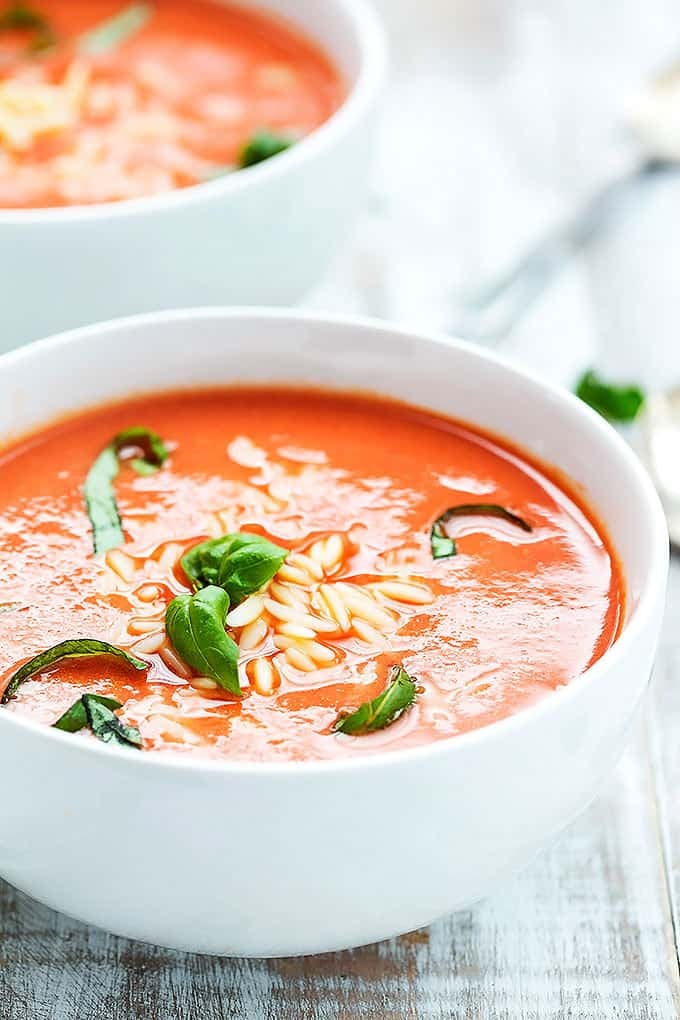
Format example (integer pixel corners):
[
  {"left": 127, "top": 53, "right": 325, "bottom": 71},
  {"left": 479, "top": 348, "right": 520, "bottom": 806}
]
[{"left": 451, "top": 159, "right": 667, "bottom": 345}]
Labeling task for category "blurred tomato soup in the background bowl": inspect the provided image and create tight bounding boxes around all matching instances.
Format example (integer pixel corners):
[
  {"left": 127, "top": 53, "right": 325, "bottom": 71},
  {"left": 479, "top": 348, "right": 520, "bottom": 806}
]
[{"left": 0, "top": 0, "right": 345, "bottom": 208}]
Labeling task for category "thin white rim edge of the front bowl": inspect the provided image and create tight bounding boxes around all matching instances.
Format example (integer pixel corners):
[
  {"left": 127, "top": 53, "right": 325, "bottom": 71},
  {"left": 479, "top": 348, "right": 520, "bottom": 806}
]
[{"left": 0, "top": 306, "right": 669, "bottom": 778}]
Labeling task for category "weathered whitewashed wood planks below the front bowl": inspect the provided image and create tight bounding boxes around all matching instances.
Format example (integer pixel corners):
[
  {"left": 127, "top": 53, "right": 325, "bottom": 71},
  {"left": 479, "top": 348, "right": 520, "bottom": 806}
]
[{"left": 0, "top": 566, "right": 680, "bottom": 1020}]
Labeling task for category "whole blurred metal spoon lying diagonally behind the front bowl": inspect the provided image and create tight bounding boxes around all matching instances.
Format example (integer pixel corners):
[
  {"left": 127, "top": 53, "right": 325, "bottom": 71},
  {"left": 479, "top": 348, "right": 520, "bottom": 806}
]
[{"left": 451, "top": 62, "right": 680, "bottom": 344}]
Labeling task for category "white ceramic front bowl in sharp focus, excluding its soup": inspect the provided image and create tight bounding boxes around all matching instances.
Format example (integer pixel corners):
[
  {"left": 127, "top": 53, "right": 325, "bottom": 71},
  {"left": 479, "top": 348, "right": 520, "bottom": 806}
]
[{"left": 0, "top": 309, "right": 668, "bottom": 956}]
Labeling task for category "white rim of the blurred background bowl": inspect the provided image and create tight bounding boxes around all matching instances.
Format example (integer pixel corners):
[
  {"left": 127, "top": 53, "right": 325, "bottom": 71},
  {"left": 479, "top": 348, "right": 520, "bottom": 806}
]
[{"left": 0, "top": 0, "right": 387, "bottom": 227}]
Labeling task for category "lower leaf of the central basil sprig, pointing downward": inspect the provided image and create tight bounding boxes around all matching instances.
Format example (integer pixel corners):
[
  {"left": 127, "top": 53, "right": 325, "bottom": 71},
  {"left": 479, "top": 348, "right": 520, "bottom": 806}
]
[{"left": 165, "top": 584, "right": 242, "bottom": 696}]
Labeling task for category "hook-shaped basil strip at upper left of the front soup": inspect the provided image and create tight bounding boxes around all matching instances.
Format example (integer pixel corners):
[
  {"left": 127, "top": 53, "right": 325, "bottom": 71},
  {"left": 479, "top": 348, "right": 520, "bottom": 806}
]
[{"left": 84, "top": 426, "right": 169, "bottom": 554}]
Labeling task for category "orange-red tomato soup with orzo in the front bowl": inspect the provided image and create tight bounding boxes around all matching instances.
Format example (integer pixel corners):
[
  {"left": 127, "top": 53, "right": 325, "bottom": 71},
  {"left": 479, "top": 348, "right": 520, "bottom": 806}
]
[{"left": 0, "top": 389, "right": 624, "bottom": 760}]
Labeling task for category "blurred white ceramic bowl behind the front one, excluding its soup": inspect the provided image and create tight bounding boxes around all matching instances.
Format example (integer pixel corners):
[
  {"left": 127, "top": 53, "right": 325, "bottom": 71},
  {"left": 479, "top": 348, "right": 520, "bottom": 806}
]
[{"left": 0, "top": 0, "right": 385, "bottom": 351}]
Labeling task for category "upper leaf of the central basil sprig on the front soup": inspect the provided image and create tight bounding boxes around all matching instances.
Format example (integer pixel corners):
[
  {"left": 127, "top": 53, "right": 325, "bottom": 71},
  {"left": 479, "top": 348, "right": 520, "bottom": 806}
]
[{"left": 181, "top": 531, "right": 287, "bottom": 607}]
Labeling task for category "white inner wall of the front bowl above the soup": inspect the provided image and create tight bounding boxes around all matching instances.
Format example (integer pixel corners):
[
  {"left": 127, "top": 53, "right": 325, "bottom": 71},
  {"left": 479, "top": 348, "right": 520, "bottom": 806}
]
[{"left": 0, "top": 309, "right": 667, "bottom": 636}]
